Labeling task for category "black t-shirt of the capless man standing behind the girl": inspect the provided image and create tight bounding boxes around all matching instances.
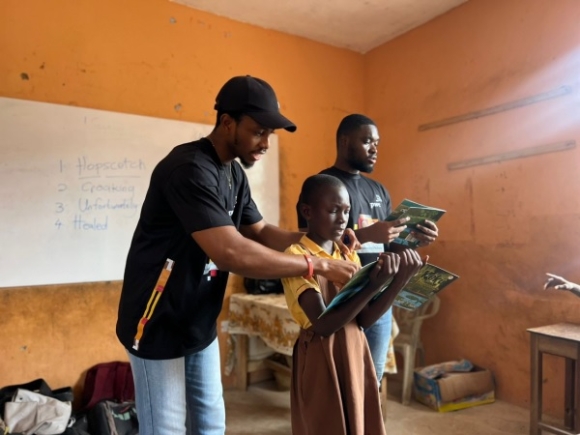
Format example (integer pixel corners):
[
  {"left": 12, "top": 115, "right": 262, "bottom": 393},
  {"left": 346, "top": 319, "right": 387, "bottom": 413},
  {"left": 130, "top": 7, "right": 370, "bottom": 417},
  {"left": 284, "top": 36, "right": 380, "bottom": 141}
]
[{"left": 296, "top": 166, "right": 391, "bottom": 266}]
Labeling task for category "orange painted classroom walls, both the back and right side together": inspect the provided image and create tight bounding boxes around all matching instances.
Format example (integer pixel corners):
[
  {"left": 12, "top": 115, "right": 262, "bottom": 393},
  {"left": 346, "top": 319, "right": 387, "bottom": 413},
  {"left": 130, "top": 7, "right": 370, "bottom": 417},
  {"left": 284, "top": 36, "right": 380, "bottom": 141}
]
[{"left": 0, "top": 0, "right": 580, "bottom": 416}]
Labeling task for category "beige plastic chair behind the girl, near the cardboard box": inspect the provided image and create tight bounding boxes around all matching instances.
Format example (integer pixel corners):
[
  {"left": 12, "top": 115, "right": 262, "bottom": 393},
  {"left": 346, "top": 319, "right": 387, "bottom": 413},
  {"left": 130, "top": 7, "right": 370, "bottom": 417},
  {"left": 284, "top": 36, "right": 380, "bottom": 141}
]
[{"left": 393, "top": 296, "right": 441, "bottom": 405}]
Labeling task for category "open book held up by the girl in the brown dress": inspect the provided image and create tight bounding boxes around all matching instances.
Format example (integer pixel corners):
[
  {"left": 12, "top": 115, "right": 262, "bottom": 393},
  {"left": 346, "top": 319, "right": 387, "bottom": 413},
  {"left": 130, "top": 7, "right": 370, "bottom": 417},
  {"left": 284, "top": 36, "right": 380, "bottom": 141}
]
[{"left": 319, "top": 261, "right": 459, "bottom": 317}]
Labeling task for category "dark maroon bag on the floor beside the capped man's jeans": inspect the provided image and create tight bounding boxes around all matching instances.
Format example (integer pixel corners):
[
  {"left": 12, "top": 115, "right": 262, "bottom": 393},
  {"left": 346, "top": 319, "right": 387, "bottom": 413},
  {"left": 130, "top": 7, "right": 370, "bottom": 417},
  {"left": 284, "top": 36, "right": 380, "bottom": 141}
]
[{"left": 81, "top": 361, "right": 135, "bottom": 411}]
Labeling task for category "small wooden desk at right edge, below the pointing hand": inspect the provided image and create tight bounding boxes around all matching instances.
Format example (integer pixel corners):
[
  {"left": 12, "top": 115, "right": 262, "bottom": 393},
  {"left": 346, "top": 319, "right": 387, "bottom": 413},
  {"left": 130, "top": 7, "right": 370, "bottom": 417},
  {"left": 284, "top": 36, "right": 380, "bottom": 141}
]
[{"left": 528, "top": 323, "right": 580, "bottom": 435}]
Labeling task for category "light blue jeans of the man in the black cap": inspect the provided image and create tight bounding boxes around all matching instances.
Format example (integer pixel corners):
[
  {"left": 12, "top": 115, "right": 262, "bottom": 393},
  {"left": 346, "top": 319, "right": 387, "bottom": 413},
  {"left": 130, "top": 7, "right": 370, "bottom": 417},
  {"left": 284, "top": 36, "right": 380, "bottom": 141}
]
[{"left": 129, "top": 339, "right": 226, "bottom": 435}]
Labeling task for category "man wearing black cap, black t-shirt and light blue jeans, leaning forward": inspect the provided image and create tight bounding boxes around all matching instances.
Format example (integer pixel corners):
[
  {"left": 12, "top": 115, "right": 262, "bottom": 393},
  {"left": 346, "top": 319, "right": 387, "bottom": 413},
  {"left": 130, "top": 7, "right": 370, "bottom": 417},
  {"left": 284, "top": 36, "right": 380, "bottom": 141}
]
[{"left": 117, "top": 76, "right": 357, "bottom": 435}]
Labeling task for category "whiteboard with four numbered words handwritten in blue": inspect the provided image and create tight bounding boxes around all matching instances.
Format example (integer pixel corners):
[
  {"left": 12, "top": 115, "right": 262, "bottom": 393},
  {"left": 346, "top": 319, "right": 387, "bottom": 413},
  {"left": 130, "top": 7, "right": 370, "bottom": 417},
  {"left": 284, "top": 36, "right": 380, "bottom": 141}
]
[{"left": 0, "top": 97, "right": 279, "bottom": 287}]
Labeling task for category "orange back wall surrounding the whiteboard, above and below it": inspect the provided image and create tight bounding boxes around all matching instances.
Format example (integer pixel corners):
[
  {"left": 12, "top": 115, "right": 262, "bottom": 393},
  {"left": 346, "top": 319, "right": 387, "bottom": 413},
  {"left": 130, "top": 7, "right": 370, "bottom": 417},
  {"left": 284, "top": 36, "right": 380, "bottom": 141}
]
[{"left": 0, "top": 0, "right": 364, "bottom": 396}]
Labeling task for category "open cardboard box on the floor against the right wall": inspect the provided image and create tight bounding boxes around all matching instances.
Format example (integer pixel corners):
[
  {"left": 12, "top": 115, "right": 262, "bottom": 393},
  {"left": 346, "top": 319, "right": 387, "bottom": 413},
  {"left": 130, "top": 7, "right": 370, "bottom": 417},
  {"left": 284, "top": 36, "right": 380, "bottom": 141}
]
[{"left": 413, "top": 363, "right": 495, "bottom": 412}]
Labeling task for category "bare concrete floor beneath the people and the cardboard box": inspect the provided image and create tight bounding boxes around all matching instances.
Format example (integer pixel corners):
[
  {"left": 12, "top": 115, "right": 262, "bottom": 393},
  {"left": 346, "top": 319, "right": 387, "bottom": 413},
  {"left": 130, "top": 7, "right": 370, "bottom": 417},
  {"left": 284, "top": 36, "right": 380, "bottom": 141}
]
[{"left": 225, "top": 381, "right": 530, "bottom": 435}]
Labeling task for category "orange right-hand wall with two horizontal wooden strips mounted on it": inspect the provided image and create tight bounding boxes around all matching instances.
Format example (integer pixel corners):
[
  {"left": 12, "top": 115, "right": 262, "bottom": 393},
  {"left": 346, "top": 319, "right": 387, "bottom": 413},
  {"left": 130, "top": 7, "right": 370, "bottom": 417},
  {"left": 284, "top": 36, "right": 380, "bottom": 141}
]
[{"left": 365, "top": 0, "right": 580, "bottom": 413}]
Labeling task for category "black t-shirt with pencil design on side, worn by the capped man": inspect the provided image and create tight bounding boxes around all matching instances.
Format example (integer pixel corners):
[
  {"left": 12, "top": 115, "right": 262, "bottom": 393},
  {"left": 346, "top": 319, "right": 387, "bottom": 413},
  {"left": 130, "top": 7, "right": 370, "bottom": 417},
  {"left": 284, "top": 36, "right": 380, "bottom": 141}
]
[{"left": 117, "top": 139, "right": 262, "bottom": 359}]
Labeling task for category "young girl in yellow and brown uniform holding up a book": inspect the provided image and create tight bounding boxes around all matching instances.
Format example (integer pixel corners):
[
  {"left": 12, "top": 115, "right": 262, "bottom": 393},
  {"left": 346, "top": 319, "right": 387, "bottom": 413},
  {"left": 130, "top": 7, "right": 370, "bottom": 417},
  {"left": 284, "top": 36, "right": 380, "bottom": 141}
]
[{"left": 282, "top": 175, "right": 422, "bottom": 435}]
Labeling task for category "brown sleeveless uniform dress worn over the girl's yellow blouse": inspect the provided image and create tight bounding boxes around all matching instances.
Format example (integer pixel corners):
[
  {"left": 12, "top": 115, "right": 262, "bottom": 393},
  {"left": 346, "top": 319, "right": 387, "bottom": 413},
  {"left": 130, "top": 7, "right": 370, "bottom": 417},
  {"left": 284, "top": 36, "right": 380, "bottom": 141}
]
[{"left": 290, "top": 277, "right": 386, "bottom": 435}]
